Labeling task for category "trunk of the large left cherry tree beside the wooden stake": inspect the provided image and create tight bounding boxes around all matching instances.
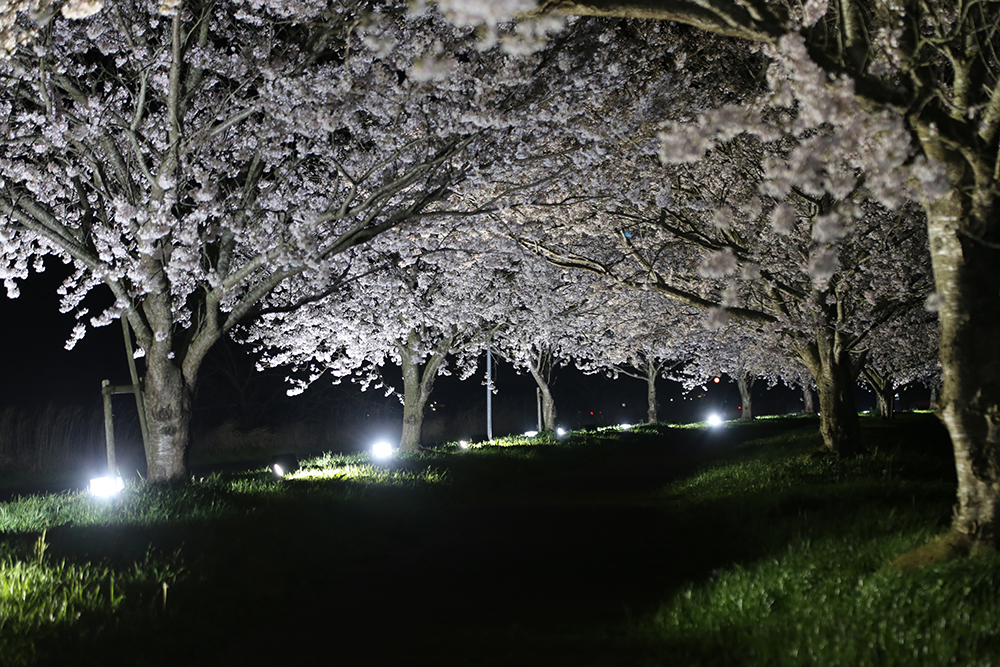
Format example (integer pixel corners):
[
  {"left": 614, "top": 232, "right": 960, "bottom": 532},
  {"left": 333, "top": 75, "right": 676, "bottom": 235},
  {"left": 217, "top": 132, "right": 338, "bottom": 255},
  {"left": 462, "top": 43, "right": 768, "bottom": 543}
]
[{"left": 144, "top": 344, "right": 194, "bottom": 482}]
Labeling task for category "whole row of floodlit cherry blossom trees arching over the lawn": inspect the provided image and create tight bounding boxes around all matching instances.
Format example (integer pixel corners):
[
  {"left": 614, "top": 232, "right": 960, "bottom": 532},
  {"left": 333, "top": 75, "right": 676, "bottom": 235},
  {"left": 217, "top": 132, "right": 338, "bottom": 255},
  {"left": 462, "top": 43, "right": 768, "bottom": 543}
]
[{"left": 0, "top": 0, "right": 980, "bottom": 560}]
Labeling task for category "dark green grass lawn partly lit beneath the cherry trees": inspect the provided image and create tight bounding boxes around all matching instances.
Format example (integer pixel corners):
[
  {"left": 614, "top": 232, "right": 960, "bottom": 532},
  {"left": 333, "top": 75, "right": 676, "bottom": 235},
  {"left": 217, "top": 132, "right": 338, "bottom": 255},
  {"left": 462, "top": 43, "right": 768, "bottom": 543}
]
[{"left": 0, "top": 414, "right": 1000, "bottom": 667}]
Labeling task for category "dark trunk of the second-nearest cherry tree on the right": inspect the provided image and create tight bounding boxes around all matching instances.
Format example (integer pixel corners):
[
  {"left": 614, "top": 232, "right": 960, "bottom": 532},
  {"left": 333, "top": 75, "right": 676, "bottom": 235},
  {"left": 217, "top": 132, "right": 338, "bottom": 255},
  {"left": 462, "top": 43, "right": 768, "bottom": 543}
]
[{"left": 799, "top": 327, "right": 861, "bottom": 456}]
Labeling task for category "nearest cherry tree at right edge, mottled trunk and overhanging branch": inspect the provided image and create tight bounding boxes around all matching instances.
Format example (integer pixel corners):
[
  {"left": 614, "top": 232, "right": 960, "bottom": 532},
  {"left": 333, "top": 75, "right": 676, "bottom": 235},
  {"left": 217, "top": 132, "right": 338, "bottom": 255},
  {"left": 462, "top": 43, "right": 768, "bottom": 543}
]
[{"left": 540, "top": 0, "right": 1000, "bottom": 558}]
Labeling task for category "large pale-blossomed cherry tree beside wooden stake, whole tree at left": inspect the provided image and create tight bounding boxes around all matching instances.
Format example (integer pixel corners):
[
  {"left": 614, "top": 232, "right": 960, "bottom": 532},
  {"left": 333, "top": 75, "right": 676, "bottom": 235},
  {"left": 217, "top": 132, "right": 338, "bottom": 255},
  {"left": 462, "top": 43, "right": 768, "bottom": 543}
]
[{"left": 0, "top": 0, "right": 568, "bottom": 481}]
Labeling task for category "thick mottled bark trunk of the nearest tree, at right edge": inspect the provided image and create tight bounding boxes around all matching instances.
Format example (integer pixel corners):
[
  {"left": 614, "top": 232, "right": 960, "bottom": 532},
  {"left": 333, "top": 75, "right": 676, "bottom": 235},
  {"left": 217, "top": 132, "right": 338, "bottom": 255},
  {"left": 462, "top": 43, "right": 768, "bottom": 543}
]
[{"left": 925, "top": 176, "right": 1000, "bottom": 547}]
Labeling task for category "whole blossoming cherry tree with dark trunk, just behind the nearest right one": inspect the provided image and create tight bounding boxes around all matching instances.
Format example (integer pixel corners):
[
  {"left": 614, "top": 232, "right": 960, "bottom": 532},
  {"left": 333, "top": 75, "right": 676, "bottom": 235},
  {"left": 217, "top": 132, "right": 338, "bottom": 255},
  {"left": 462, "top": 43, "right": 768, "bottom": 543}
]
[{"left": 523, "top": 134, "right": 929, "bottom": 455}]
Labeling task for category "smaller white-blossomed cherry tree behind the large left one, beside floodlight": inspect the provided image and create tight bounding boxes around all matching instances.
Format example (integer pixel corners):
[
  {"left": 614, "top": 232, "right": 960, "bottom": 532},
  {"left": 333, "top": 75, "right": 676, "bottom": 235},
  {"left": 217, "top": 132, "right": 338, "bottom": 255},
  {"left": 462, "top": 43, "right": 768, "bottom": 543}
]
[{"left": 248, "top": 225, "right": 520, "bottom": 452}]
